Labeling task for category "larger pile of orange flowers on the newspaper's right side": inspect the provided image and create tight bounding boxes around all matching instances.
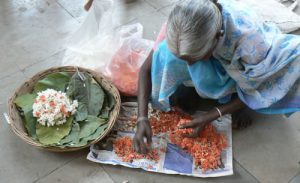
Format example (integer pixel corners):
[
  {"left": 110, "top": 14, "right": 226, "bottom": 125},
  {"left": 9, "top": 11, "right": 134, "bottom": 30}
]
[{"left": 150, "top": 111, "right": 228, "bottom": 172}]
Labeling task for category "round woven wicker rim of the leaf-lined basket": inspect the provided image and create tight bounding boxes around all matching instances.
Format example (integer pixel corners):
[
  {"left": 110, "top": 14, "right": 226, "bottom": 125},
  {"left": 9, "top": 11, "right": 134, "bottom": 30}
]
[{"left": 8, "top": 66, "right": 121, "bottom": 152}]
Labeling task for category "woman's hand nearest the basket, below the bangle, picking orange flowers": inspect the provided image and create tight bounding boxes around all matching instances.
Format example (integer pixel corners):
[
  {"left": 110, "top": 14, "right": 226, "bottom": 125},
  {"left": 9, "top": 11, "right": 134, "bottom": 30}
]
[{"left": 133, "top": 118, "right": 152, "bottom": 154}]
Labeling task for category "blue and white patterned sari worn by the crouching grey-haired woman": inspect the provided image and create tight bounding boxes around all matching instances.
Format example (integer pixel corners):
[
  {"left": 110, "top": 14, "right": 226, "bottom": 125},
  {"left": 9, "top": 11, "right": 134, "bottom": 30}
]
[{"left": 151, "top": 0, "right": 300, "bottom": 114}]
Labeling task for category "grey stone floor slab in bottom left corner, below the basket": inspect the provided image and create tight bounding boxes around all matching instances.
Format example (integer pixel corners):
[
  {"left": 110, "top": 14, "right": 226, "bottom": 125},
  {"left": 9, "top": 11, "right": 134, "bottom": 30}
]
[{"left": 0, "top": 105, "right": 87, "bottom": 183}]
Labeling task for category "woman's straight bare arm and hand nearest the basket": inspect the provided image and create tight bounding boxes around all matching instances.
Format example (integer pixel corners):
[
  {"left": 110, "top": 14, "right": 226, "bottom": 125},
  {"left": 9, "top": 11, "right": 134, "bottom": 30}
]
[{"left": 133, "top": 51, "right": 153, "bottom": 154}]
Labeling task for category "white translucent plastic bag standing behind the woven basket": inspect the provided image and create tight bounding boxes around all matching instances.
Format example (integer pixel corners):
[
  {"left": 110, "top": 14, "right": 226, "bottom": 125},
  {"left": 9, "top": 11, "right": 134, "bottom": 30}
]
[{"left": 62, "top": 0, "right": 118, "bottom": 71}]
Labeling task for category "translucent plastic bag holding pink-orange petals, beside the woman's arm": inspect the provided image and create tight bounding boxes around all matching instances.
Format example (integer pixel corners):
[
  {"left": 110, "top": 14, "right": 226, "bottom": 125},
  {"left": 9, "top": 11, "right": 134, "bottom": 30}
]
[{"left": 104, "top": 38, "right": 153, "bottom": 96}]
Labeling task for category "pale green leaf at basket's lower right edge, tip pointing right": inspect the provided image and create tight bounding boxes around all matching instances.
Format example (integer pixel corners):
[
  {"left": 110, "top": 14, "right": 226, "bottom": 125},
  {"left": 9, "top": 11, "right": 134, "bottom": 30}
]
[{"left": 79, "top": 116, "right": 107, "bottom": 139}]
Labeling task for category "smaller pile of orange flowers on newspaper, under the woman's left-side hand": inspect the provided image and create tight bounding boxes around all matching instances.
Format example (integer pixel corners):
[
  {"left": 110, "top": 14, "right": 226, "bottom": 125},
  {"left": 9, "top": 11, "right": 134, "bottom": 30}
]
[{"left": 113, "top": 136, "right": 159, "bottom": 162}]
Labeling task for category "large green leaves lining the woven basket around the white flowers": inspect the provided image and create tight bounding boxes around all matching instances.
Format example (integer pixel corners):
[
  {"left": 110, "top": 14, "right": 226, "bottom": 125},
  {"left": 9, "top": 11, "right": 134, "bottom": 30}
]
[{"left": 14, "top": 72, "right": 115, "bottom": 148}]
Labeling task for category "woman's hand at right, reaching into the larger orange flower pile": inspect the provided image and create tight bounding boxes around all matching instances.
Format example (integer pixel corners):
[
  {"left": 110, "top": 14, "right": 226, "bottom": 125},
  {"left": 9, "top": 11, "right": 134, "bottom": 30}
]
[{"left": 179, "top": 110, "right": 219, "bottom": 138}]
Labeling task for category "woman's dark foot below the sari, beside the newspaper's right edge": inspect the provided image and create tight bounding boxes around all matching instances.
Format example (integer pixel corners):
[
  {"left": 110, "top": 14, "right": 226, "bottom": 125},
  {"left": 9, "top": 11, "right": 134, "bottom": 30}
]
[{"left": 232, "top": 109, "right": 252, "bottom": 129}]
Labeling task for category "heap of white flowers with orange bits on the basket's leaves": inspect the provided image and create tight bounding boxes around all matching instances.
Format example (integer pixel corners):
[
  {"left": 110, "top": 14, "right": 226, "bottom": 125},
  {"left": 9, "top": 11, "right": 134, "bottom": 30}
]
[{"left": 32, "top": 89, "right": 78, "bottom": 127}]
